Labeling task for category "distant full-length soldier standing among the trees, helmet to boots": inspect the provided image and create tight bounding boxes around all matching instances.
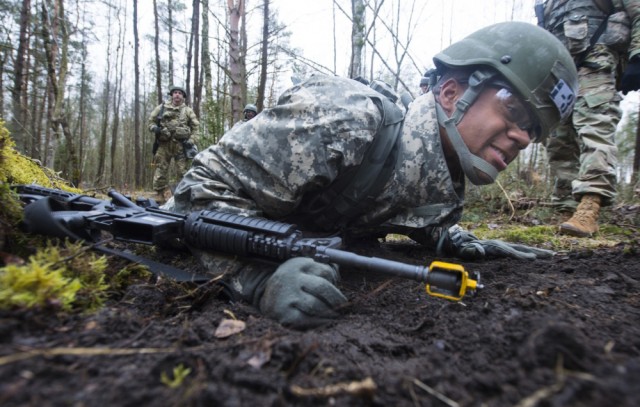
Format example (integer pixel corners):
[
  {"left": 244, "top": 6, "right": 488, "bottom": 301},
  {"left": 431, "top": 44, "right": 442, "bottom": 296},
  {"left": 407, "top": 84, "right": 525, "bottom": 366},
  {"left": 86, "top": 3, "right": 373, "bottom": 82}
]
[{"left": 147, "top": 86, "right": 200, "bottom": 202}]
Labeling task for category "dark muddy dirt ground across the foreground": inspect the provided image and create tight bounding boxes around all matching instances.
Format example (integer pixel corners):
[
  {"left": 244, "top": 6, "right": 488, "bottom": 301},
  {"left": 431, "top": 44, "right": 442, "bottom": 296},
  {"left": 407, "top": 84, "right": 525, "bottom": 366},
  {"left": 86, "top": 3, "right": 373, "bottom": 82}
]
[{"left": 0, "top": 210, "right": 640, "bottom": 407}]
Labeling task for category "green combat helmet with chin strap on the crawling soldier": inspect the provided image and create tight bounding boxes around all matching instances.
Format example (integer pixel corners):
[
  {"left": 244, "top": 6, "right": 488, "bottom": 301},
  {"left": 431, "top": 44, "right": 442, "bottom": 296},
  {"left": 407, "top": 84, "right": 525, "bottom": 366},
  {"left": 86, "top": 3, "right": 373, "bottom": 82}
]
[{"left": 433, "top": 22, "right": 578, "bottom": 185}]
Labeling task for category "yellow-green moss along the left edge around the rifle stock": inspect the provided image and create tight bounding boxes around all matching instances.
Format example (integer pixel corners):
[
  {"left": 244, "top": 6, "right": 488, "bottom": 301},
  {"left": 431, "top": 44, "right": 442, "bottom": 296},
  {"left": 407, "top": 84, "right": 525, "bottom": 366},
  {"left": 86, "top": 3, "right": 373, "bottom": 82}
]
[{"left": 0, "top": 120, "right": 156, "bottom": 312}]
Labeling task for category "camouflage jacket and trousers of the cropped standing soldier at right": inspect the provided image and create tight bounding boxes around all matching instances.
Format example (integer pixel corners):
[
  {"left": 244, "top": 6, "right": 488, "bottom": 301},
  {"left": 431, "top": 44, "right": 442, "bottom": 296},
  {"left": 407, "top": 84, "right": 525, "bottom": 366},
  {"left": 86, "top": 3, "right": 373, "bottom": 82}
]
[{"left": 545, "top": 0, "right": 640, "bottom": 209}]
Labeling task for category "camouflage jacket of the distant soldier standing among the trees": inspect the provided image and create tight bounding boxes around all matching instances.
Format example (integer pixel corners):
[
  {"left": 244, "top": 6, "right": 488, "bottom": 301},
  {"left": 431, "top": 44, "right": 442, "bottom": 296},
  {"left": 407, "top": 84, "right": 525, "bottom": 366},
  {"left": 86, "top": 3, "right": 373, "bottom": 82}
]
[{"left": 147, "top": 100, "right": 200, "bottom": 142}]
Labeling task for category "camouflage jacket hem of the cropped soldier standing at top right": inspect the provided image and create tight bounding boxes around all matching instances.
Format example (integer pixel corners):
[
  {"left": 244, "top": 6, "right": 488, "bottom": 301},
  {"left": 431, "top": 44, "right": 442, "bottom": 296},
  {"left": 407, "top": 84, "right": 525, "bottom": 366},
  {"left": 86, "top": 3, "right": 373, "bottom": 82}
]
[{"left": 544, "top": 0, "right": 640, "bottom": 58}]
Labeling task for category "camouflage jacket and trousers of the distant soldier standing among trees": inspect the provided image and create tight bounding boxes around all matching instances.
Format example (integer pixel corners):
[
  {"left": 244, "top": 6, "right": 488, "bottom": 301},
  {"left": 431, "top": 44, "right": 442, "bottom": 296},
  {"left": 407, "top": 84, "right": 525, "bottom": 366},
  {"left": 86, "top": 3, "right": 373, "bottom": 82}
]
[{"left": 147, "top": 100, "right": 200, "bottom": 191}]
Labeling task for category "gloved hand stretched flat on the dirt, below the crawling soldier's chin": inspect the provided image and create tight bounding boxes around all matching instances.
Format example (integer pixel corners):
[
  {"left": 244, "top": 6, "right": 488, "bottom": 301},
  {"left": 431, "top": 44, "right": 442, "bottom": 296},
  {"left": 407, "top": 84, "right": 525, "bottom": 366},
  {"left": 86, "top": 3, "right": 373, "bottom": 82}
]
[{"left": 438, "top": 225, "right": 555, "bottom": 260}]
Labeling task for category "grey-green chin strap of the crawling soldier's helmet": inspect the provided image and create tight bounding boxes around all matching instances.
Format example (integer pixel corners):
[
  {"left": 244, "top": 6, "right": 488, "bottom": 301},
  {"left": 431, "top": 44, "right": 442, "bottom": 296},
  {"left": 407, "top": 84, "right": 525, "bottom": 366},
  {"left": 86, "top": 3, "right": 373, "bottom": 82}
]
[{"left": 436, "top": 70, "right": 498, "bottom": 185}]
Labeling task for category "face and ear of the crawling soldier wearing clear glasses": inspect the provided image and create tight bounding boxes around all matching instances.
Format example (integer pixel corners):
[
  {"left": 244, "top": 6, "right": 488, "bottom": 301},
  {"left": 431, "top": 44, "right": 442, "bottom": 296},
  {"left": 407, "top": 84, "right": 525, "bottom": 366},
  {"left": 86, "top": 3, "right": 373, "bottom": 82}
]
[{"left": 440, "top": 80, "right": 535, "bottom": 183}]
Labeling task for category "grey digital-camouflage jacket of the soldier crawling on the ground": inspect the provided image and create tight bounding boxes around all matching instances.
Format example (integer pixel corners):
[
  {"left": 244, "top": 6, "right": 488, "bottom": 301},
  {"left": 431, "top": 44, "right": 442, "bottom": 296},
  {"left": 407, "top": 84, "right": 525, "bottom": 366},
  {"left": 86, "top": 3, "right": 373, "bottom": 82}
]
[{"left": 172, "top": 76, "right": 464, "bottom": 249}]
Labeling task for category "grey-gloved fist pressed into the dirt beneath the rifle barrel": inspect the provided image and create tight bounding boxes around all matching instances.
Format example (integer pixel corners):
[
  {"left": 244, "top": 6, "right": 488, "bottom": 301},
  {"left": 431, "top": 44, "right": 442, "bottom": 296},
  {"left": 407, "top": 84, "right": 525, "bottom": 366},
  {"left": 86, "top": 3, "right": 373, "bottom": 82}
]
[{"left": 259, "top": 257, "right": 347, "bottom": 329}]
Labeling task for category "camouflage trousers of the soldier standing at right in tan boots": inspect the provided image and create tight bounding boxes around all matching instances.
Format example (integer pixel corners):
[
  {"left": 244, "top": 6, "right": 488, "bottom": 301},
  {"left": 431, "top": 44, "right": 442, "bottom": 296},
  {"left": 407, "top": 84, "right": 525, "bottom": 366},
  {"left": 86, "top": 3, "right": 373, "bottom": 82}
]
[{"left": 546, "top": 45, "right": 622, "bottom": 209}]
